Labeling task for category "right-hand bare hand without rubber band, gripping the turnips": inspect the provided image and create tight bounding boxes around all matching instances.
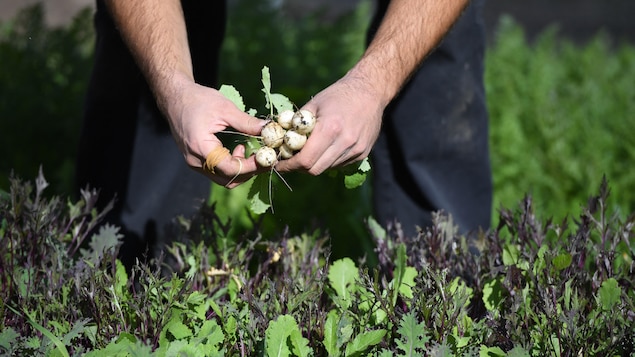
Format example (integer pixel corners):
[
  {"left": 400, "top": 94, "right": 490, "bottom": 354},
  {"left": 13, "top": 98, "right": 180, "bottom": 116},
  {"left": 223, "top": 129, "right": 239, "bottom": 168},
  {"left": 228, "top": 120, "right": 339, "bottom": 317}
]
[{"left": 276, "top": 75, "right": 385, "bottom": 175}]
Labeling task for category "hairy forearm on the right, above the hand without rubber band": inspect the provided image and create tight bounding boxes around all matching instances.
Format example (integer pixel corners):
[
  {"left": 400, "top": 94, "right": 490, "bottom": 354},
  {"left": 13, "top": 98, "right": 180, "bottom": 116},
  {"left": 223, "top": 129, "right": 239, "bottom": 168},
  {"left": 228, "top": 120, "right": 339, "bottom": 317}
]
[{"left": 349, "top": 0, "right": 469, "bottom": 105}]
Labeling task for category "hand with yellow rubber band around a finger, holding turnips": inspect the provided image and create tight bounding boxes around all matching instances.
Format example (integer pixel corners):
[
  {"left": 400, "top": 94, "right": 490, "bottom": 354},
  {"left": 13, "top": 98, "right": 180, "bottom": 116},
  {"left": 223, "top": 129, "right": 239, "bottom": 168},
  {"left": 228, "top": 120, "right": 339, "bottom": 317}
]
[{"left": 163, "top": 81, "right": 266, "bottom": 188}]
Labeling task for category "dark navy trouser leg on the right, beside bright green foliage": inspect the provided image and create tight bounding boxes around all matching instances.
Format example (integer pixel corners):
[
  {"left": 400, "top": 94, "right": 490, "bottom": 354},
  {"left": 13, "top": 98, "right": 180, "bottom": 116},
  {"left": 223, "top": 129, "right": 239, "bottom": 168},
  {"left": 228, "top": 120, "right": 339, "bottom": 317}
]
[{"left": 369, "top": 0, "right": 492, "bottom": 236}]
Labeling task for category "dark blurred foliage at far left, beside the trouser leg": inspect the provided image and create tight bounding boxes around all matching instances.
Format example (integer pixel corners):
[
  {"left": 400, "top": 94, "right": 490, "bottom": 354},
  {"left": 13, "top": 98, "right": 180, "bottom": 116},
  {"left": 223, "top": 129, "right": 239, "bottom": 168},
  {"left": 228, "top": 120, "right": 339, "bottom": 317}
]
[{"left": 0, "top": 3, "right": 93, "bottom": 193}]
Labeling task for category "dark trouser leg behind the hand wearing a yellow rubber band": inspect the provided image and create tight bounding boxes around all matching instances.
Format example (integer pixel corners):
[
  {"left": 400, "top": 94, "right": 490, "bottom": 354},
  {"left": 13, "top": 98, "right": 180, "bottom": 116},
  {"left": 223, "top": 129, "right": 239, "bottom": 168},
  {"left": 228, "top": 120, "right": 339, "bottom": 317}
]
[{"left": 76, "top": 0, "right": 226, "bottom": 264}]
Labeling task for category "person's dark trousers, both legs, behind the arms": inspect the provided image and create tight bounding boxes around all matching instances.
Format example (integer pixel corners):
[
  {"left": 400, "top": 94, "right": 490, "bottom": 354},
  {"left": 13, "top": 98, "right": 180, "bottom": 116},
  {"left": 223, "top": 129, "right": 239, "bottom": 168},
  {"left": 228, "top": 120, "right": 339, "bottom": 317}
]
[{"left": 77, "top": 0, "right": 492, "bottom": 265}]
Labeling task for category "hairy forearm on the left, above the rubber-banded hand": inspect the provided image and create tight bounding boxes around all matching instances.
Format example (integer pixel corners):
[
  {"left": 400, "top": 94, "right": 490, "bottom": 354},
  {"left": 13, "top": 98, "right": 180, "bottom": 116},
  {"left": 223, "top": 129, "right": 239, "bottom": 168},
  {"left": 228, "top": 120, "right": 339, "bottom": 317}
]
[{"left": 106, "top": 0, "right": 193, "bottom": 116}]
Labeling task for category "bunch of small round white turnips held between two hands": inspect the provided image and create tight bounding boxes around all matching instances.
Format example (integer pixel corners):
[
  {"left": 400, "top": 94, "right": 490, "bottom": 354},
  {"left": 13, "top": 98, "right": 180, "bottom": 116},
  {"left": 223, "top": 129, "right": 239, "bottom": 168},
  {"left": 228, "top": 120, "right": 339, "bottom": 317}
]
[{"left": 256, "top": 109, "right": 316, "bottom": 167}]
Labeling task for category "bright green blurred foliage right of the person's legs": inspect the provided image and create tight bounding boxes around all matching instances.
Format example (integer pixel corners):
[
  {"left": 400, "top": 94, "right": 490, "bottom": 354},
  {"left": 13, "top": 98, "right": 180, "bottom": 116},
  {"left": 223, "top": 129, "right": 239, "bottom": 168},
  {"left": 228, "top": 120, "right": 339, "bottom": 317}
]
[{"left": 485, "top": 17, "right": 635, "bottom": 221}]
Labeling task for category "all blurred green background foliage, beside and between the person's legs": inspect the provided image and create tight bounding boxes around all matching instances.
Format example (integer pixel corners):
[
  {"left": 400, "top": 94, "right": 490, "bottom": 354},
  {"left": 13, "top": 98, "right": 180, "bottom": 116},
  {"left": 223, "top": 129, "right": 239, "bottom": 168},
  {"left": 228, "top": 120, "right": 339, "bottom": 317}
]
[{"left": 0, "top": 0, "right": 635, "bottom": 255}]
